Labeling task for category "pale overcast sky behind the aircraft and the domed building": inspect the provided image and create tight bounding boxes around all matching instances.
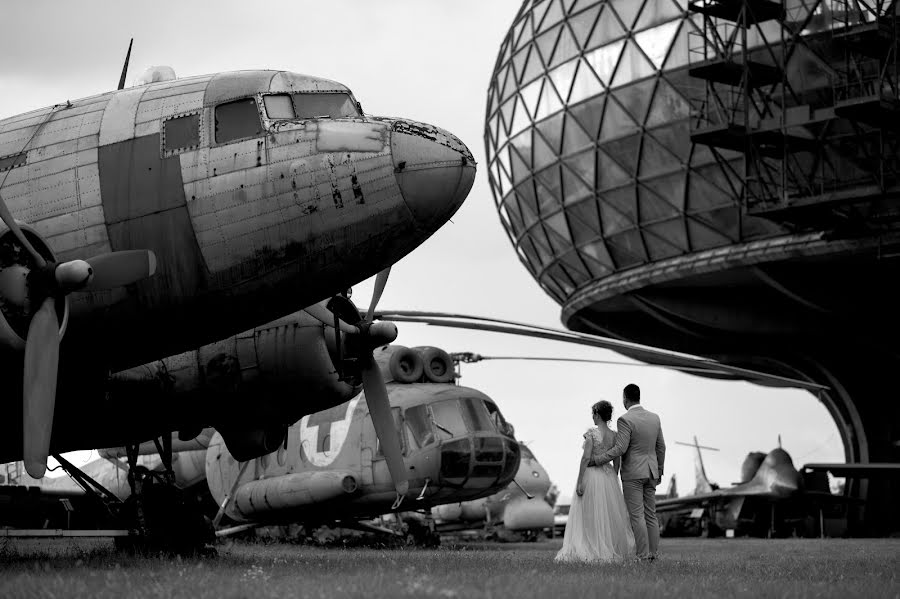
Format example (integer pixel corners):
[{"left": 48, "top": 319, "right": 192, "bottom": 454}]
[{"left": 0, "top": 0, "right": 844, "bottom": 496}]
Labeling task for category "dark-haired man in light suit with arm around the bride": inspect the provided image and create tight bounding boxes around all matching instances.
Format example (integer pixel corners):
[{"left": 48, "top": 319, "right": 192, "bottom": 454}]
[{"left": 590, "top": 384, "right": 666, "bottom": 560}]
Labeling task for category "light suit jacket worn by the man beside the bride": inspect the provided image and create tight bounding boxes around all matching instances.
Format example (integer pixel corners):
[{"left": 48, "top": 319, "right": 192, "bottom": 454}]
[{"left": 600, "top": 405, "right": 666, "bottom": 480}]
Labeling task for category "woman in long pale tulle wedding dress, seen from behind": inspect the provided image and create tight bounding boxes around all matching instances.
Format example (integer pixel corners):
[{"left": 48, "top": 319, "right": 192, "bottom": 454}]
[{"left": 556, "top": 401, "right": 635, "bottom": 562}]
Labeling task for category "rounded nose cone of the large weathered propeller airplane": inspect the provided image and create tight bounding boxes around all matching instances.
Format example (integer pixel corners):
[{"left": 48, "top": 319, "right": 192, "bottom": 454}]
[{"left": 391, "top": 121, "right": 475, "bottom": 230}]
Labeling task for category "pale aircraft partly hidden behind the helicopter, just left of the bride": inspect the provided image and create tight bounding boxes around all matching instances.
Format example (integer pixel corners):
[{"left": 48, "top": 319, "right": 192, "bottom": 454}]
[{"left": 434, "top": 443, "right": 553, "bottom": 540}]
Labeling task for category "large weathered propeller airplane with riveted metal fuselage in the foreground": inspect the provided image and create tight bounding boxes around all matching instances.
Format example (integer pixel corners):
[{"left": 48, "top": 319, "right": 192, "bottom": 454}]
[{"left": 0, "top": 51, "right": 475, "bottom": 490}]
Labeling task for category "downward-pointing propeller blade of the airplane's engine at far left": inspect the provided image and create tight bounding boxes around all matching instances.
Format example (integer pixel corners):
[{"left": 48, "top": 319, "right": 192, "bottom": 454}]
[{"left": 22, "top": 297, "right": 59, "bottom": 478}]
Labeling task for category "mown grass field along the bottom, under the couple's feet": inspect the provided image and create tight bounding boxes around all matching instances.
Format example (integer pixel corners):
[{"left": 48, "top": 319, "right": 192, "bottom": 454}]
[{"left": 0, "top": 539, "right": 900, "bottom": 599}]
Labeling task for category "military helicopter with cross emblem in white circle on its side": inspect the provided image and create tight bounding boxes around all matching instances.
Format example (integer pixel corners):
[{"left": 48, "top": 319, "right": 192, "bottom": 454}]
[{"left": 206, "top": 345, "right": 520, "bottom": 532}]
